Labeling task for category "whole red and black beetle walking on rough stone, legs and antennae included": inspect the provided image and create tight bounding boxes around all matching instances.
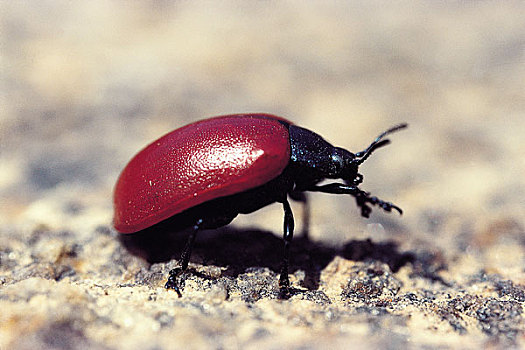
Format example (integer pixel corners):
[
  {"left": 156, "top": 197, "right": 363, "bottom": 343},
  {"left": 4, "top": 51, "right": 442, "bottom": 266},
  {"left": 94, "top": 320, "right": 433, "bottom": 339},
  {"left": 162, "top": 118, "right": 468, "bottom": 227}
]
[{"left": 113, "top": 113, "right": 407, "bottom": 296}]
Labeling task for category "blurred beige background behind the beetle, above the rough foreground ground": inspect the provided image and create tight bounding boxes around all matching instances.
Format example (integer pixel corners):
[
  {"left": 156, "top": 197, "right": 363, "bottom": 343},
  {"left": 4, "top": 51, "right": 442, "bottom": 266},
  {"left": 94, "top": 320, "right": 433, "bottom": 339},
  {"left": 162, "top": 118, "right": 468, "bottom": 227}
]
[{"left": 0, "top": 0, "right": 525, "bottom": 348}]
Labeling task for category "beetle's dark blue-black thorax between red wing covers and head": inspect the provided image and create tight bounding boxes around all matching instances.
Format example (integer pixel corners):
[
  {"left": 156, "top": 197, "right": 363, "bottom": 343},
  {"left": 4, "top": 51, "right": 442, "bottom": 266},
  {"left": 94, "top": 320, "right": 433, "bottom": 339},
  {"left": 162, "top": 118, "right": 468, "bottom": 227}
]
[{"left": 289, "top": 125, "right": 357, "bottom": 189}]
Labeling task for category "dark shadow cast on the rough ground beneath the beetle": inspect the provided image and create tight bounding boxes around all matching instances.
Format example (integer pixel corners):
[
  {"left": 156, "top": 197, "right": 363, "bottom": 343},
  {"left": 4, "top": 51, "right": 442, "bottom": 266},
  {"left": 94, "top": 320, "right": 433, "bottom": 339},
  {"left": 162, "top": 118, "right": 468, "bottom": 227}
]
[{"left": 119, "top": 226, "right": 417, "bottom": 290}]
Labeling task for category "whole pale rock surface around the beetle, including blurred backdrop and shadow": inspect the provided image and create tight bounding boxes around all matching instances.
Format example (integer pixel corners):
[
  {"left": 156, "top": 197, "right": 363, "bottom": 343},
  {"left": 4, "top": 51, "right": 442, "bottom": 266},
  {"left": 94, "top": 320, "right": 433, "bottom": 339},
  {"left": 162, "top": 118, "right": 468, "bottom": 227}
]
[{"left": 0, "top": 1, "right": 525, "bottom": 350}]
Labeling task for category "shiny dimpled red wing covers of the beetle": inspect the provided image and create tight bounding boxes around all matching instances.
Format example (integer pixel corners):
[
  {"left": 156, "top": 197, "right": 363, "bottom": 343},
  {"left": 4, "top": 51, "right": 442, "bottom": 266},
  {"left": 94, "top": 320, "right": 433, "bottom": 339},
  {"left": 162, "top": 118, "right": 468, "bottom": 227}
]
[{"left": 113, "top": 114, "right": 291, "bottom": 233}]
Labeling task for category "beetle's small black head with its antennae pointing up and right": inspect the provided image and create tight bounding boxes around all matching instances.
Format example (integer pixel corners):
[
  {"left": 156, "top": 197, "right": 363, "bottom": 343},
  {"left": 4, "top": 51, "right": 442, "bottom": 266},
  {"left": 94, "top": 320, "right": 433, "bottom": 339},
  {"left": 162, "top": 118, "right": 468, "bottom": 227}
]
[{"left": 331, "top": 123, "right": 408, "bottom": 186}]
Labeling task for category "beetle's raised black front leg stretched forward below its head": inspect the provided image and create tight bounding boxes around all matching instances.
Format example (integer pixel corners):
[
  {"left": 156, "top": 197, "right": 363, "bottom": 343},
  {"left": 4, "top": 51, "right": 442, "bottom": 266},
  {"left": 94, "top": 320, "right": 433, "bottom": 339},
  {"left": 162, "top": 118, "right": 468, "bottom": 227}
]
[{"left": 308, "top": 183, "right": 403, "bottom": 218}]
